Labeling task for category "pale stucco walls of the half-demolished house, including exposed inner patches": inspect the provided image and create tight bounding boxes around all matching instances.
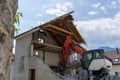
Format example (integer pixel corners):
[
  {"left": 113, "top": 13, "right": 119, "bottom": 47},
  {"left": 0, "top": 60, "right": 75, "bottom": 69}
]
[{"left": 10, "top": 30, "right": 59, "bottom": 80}]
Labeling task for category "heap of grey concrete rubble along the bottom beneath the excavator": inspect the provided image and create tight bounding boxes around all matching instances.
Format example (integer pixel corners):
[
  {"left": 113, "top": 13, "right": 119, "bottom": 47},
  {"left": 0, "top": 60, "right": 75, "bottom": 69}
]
[{"left": 54, "top": 69, "right": 120, "bottom": 80}]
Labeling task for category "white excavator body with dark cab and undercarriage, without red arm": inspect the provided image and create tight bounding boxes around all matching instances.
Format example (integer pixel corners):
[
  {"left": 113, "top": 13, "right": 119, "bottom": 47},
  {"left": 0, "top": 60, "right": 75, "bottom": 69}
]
[{"left": 81, "top": 49, "right": 120, "bottom": 80}]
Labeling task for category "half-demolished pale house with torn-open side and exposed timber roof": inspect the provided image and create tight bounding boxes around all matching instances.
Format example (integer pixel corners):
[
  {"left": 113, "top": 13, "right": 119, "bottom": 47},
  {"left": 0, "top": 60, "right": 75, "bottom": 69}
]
[{"left": 10, "top": 12, "right": 85, "bottom": 80}]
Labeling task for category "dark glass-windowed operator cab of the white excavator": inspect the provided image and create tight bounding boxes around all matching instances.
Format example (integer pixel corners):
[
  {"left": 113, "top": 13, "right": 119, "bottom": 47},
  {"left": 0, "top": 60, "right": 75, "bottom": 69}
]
[{"left": 81, "top": 49, "right": 104, "bottom": 70}]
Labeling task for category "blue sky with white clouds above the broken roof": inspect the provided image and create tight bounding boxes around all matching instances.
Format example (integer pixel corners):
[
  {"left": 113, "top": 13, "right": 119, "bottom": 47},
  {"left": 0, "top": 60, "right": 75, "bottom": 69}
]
[{"left": 18, "top": 0, "right": 120, "bottom": 49}]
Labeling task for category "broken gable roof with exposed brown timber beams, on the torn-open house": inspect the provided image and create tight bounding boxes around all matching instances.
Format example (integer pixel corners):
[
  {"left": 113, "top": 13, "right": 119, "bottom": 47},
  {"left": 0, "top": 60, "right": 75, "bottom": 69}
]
[{"left": 15, "top": 12, "right": 86, "bottom": 46}]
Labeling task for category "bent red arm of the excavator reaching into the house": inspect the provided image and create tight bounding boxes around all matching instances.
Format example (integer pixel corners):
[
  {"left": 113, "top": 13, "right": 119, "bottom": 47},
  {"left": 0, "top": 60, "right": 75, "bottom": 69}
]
[{"left": 62, "top": 36, "right": 86, "bottom": 66}]
